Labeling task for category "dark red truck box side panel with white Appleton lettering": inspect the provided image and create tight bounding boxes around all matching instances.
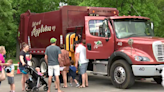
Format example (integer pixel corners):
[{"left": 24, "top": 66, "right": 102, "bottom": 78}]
[{"left": 28, "top": 11, "right": 62, "bottom": 48}]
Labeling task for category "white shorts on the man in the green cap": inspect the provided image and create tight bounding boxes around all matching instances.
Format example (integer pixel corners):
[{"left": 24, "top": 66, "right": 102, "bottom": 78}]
[{"left": 48, "top": 65, "right": 60, "bottom": 76}]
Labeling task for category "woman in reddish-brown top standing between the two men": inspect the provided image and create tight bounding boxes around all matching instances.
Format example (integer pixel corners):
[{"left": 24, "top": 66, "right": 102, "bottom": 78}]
[{"left": 59, "top": 44, "right": 70, "bottom": 88}]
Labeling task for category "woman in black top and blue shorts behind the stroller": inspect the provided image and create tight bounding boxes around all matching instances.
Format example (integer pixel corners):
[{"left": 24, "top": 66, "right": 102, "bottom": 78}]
[{"left": 19, "top": 43, "right": 29, "bottom": 91}]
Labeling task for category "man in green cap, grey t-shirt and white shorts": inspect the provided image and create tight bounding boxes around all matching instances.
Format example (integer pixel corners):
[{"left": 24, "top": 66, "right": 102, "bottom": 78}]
[{"left": 45, "top": 38, "right": 63, "bottom": 92}]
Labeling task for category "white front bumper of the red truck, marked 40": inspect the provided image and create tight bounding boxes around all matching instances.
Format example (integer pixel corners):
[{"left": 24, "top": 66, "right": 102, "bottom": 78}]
[{"left": 132, "top": 65, "right": 164, "bottom": 77}]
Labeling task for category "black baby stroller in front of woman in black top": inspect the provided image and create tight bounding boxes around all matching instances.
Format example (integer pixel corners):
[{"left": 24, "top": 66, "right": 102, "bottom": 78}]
[{"left": 24, "top": 66, "right": 48, "bottom": 92}]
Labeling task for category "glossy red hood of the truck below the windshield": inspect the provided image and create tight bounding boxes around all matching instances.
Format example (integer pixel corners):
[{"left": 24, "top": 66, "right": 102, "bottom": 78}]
[{"left": 116, "top": 37, "right": 164, "bottom": 63}]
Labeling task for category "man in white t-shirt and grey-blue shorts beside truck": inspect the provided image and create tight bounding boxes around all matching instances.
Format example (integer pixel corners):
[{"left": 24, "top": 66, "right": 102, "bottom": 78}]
[{"left": 75, "top": 41, "right": 89, "bottom": 88}]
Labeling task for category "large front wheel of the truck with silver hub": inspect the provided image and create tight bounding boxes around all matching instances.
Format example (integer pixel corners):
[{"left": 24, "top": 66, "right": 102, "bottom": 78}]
[{"left": 110, "top": 60, "right": 135, "bottom": 89}]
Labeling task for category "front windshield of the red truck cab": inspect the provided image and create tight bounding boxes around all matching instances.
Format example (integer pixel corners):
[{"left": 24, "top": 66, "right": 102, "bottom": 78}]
[{"left": 114, "top": 19, "right": 154, "bottom": 38}]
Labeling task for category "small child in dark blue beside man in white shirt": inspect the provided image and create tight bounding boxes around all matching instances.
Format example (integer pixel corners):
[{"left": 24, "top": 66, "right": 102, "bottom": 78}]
[{"left": 69, "top": 60, "right": 80, "bottom": 87}]
